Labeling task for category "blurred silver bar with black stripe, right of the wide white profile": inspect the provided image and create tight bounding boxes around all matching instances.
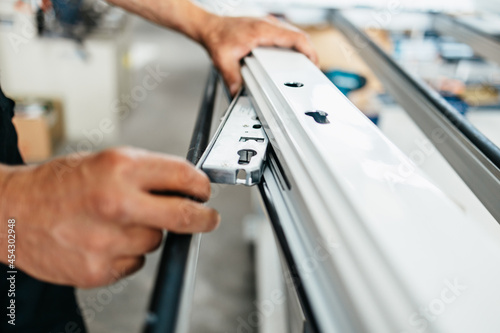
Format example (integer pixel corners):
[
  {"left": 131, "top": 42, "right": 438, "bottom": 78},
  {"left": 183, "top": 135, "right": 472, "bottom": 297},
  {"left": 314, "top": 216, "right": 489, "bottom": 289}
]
[{"left": 332, "top": 11, "right": 500, "bottom": 222}]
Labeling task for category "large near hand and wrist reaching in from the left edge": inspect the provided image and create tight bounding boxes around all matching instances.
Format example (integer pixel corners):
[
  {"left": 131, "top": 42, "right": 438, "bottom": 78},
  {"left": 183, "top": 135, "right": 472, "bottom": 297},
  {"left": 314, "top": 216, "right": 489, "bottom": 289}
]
[{"left": 0, "top": 148, "right": 219, "bottom": 287}]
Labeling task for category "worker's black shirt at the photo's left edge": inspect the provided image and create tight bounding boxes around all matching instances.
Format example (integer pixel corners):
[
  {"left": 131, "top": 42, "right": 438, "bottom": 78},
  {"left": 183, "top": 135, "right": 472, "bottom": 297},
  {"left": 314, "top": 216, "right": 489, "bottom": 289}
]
[{"left": 0, "top": 86, "right": 85, "bottom": 333}]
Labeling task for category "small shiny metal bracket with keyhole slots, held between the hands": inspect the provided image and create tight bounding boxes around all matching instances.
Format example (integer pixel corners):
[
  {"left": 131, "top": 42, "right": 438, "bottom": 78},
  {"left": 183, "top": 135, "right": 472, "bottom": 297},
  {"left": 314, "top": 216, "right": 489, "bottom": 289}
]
[{"left": 201, "top": 94, "right": 269, "bottom": 186}]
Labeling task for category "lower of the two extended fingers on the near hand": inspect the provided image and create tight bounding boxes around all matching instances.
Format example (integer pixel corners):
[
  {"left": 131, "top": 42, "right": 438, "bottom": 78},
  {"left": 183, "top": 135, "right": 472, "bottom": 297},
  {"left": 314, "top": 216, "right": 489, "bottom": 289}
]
[{"left": 130, "top": 194, "right": 220, "bottom": 233}]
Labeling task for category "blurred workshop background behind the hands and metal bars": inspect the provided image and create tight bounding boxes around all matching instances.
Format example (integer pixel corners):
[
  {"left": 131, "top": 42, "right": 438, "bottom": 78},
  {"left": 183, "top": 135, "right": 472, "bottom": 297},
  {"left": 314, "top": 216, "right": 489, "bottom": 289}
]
[{"left": 0, "top": 0, "right": 500, "bottom": 333}]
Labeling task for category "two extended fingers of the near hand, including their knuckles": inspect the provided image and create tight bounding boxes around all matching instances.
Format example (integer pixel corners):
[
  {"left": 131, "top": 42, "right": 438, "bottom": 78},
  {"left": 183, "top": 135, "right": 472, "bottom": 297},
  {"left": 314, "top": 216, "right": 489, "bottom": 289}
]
[{"left": 87, "top": 149, "right": 218, "bottom": 231}]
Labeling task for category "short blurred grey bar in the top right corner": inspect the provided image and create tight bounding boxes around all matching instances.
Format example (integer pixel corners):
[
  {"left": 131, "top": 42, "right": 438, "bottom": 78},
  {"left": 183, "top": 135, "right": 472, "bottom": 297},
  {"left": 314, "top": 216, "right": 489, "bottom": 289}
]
[{"left": 434, "top": 14, "right": 500, "bottom": 65}]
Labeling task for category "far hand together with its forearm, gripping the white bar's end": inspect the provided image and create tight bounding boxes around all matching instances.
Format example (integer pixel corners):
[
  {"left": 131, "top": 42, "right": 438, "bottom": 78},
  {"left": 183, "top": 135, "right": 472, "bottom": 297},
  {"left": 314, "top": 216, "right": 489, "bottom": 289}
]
[{"left": 107, "top": 0, "right": 318, "bottom": 95}]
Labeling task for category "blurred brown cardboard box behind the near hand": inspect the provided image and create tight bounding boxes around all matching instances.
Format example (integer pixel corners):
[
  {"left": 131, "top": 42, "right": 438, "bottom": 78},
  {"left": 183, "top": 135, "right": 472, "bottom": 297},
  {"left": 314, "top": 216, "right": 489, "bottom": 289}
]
[{"left": 12, "top": 99, "right": 64, "bottom": 163}]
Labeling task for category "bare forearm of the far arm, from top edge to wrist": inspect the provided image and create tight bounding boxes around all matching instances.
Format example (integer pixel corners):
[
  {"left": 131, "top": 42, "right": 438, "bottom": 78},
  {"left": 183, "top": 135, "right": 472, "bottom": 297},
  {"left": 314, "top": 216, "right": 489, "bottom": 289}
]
[{"left": 107, "top": 0, "right": 217, "bottom": 43}]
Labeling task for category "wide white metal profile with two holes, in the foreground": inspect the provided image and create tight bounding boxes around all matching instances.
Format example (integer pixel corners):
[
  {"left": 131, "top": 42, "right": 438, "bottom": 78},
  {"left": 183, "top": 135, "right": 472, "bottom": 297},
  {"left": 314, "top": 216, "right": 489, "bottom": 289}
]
[{"left": 242, "top": 48, "right": 500, "bottom": 333}]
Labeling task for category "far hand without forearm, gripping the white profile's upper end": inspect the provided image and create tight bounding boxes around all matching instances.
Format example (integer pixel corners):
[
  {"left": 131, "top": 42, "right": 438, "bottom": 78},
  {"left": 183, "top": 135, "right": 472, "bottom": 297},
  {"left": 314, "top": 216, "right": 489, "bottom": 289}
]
[{"left": 202, "top": 16, "right": 318, "bottom": 95}]
